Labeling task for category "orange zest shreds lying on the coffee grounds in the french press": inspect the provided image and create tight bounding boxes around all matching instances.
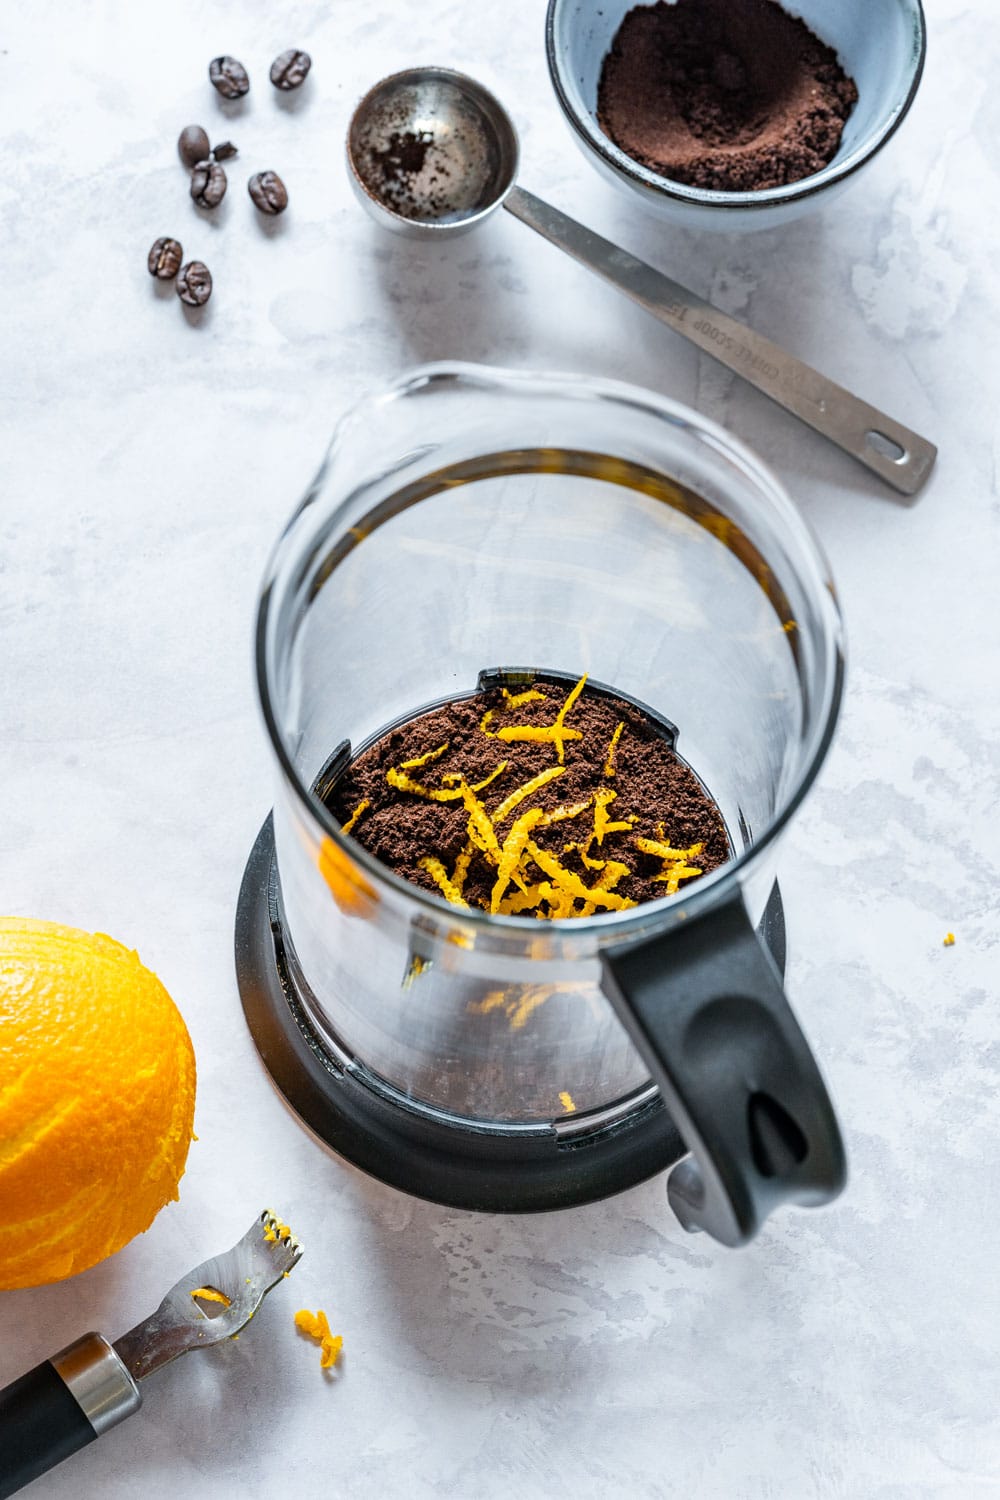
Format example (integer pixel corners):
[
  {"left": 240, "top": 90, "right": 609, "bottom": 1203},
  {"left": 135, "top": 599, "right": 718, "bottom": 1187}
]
[{"left": 374, "top": 674, "right": 703, "bottom": 918}]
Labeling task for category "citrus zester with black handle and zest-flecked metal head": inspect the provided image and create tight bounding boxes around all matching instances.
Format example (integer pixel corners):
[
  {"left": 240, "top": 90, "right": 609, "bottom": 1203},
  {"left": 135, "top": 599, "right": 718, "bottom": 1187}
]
[{"left": 0, "top": 1209, "right": 301, "bottom": 1500}]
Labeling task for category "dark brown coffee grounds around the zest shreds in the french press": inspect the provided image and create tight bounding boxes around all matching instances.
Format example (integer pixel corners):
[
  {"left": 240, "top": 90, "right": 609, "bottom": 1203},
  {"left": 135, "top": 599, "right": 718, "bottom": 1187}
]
[{"left": 328, "top": 680, "right": 732, "bottom": 918}]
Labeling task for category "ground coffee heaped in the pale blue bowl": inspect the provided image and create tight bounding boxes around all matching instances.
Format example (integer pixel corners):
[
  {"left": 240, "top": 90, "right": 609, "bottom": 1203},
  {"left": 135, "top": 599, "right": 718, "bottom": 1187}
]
[{"left": 597, "top": 0, "right": 858, "bottom": 192}]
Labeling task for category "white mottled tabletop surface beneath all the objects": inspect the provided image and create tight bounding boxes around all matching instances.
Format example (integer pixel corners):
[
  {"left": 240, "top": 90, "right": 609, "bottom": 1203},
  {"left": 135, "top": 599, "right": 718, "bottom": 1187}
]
[{"left": 0, "top": 0, "right": 1000, "bottom": 1500}]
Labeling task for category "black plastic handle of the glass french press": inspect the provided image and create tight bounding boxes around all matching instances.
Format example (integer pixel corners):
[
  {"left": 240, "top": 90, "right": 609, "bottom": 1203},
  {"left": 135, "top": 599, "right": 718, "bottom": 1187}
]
[{"left": 601, "top": 893, "right": 847, "bottom": 1245}]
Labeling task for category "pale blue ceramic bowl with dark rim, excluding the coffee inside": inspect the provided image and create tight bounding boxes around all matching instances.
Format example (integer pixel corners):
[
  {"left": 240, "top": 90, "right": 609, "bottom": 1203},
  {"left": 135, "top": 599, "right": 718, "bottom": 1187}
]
[{"left": 546, "top": 0, "right": 927, "bottom": 230}]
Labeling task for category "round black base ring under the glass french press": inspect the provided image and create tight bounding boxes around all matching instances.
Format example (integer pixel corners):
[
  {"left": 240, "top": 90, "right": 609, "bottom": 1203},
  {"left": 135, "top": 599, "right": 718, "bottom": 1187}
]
[{"left": 235, "top": 818, "right": 786, "bottom": 1214}]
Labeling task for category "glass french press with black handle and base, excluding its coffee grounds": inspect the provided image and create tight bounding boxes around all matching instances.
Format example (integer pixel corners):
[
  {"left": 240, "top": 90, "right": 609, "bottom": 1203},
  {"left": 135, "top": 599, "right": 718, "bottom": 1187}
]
[{"left": 237, "top": 365, "right": 844, "bottom": 1245}]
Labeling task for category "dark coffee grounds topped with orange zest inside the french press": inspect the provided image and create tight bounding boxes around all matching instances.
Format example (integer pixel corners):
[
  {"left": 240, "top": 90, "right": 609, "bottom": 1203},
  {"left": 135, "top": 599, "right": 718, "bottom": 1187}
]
[{"left": 328, "top": 678, "right": 732, "bottom": 920}]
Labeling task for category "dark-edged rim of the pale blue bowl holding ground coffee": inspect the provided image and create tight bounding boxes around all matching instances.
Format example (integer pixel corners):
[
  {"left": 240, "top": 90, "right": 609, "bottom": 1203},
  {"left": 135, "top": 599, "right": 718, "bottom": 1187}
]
[{"left": 546, "top": 0, "right": 927, "bottom": 210}]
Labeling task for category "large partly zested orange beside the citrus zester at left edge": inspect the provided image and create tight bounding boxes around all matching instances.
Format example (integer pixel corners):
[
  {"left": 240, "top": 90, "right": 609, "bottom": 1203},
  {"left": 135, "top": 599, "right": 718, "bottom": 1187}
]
[{"left": 0, "top": 917, "right": 195, "bottom": 1290}]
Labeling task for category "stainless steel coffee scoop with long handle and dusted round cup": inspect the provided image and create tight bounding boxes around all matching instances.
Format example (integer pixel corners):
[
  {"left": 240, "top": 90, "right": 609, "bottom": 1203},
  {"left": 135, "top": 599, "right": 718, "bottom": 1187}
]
[{"left": 348, "top": 68, "right": 937, "bottom": 495}]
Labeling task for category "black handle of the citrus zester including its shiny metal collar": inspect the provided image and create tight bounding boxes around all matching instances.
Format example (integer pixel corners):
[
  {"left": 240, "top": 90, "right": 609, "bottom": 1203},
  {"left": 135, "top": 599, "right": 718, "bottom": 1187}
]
[{"left": 0, "top": 1334, "right": 142, "bottom": 1500}]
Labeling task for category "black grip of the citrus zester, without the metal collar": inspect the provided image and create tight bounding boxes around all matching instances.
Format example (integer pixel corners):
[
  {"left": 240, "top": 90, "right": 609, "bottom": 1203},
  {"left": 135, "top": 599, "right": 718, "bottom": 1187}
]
[{"left": 0, "top": 1359, "right": 97, "bottom": 1500}]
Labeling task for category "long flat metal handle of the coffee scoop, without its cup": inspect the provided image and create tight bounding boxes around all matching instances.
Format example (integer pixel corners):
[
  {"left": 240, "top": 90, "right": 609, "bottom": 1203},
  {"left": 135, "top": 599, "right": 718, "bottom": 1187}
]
[{"left": 504, "top": 188, "right": 937, "bottom": 495}]
